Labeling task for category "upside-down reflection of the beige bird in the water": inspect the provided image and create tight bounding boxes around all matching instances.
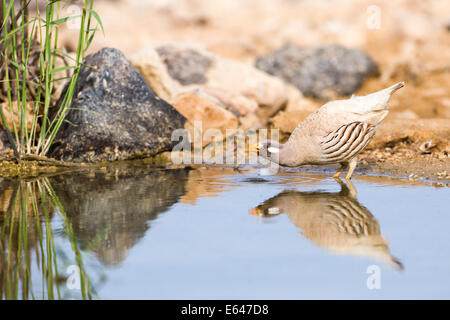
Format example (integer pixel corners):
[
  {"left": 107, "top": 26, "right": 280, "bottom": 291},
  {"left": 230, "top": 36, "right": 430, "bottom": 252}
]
[{"left": 250, "top": 180, "right": 403, "bottom": 270}]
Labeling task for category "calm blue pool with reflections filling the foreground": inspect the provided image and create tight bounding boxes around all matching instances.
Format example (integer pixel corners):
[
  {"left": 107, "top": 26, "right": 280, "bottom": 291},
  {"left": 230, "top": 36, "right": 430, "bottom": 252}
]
[{"left": 0, "top": 167, "right": 450, "bottom": 299}]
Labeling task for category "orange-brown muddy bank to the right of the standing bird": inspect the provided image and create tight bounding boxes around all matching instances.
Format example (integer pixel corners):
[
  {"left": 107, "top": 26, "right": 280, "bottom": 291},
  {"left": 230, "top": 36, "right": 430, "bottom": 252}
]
[{"left": 359, "top": 119, "right": 450, "bottom": 186}]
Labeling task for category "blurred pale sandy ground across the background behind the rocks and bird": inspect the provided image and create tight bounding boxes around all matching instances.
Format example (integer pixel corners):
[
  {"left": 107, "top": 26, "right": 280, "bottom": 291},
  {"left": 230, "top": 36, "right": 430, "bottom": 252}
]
[{"left": 61, "top": 0, "right": 450, "bottom": 118}]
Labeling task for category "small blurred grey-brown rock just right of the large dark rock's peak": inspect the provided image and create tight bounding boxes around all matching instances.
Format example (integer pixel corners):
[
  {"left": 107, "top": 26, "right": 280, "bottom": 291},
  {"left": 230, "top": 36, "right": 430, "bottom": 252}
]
[{"left": 156, "top": 45, "right": 212, "bottom": 86}]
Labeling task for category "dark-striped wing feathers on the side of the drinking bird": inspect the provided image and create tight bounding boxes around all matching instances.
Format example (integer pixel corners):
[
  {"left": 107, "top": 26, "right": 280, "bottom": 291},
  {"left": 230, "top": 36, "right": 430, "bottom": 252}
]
[{"left": 319, "top": 121, "right": 376, "bottom": 162}]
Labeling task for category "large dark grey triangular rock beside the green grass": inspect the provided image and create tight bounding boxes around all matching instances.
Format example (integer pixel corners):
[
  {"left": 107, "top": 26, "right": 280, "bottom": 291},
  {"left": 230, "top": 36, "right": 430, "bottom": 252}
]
[{"left": 49, "top": 48, "right": 186, "bottom": 162}]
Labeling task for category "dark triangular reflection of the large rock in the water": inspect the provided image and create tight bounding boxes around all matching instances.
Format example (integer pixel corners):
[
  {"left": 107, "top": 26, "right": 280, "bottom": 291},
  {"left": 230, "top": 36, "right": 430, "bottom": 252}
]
[{"left": 50, "top": 168, "right": 189, "bottom": 265}]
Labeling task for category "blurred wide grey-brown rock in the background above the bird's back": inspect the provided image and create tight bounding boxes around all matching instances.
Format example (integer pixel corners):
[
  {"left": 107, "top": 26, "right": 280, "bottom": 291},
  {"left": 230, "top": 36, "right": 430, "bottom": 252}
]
[{"left": 255, "top": 44, "right": 378, "bottom": 100}]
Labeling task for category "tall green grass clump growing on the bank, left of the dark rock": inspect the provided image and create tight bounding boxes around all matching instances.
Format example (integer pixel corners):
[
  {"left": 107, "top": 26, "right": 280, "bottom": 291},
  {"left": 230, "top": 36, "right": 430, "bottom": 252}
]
[{"left": 0, "top": 0, "right": 103, "bottom": 160}]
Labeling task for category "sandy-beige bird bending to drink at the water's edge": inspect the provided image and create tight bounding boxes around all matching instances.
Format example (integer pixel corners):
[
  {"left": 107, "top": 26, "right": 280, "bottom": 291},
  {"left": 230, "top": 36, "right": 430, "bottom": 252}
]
[{"left": 249, "top": 82, "right": 405, "bottom": 181}]
